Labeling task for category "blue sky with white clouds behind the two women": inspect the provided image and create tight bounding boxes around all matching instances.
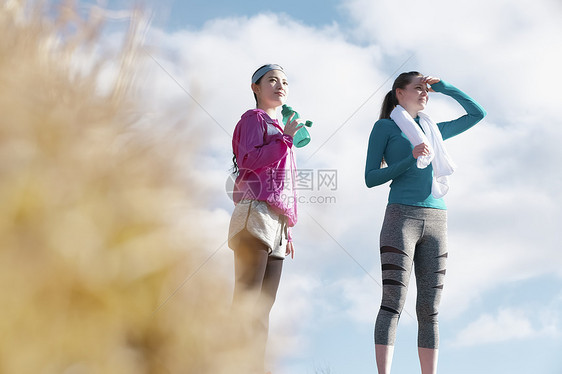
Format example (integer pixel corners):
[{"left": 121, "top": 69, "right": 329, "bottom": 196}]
[{"left": 88, "top": 0, "right": 562, "bottom": 374}]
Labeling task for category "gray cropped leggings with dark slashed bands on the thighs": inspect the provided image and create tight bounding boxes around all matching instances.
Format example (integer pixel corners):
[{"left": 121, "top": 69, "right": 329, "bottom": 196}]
[{"left": 375, "top": 204, "right": 447, "bottom": 348}]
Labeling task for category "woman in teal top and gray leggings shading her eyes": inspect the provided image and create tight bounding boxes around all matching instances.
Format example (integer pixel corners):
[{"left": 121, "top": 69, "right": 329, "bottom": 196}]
[{"left": 365, "top": 72, "right": 486, "bottom": 374}]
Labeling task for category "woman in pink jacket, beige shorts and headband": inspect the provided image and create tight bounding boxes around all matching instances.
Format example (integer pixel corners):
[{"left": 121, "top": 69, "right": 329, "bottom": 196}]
[{"left": 228, "top": 64, "right": 304, "bottom": 373}]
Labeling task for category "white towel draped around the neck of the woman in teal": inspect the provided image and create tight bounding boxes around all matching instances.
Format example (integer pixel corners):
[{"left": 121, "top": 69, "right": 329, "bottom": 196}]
[{"left": 390, "top": 105, "right": 456, "bottom": 198}]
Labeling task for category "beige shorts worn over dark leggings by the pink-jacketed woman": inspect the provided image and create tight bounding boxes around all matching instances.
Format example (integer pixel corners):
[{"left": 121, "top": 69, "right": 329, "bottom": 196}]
[{"left": 228, "top": 200, "right": 287, "bottom": 258}]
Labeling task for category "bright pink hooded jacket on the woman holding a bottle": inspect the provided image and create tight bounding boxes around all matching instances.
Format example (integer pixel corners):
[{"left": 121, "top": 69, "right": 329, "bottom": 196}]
[{"left": 232, "top": 109, "right": 297, "bottom": 239}]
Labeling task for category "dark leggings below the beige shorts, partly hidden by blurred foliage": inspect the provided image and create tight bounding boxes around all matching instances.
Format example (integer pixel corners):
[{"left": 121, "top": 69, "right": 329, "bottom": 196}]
[{"left": 232, "top": 231, "right": 283, "bottom": 372}]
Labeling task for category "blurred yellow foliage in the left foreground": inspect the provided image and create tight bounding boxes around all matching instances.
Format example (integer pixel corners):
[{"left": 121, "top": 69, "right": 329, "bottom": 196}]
[{"left": 0, "top": 0, "right": 258, "bottom": 374}]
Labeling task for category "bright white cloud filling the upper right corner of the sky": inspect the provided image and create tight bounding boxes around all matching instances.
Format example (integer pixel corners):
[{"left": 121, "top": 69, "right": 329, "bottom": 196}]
[{"left": 345, "top": 0, "right": 562, "bottom": 118}]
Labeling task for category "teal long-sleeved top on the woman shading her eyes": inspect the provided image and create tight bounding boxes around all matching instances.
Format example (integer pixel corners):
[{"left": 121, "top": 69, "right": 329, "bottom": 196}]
[{"left": 365, "top": 81, "right": 486, "bottom": 209}]
